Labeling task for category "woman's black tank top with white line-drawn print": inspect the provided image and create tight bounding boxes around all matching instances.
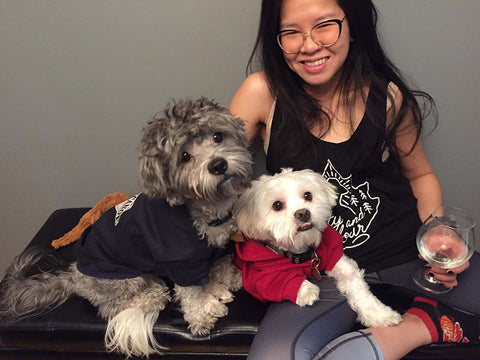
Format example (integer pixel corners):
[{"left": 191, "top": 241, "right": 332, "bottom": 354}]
[{"left": 266, "top": 85, "right": 421, "bottom": 272}]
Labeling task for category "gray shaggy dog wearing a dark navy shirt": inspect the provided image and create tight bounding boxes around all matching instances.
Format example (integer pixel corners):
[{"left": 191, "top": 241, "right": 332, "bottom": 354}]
[{"left": 0, "top": 98, "right": 252, "bottom": 357}]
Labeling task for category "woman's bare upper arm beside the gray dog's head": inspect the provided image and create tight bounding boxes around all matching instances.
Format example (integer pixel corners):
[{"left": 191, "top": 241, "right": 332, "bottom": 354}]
[{"left": 230, "top": 72, "right": 273, "bottom": 143}]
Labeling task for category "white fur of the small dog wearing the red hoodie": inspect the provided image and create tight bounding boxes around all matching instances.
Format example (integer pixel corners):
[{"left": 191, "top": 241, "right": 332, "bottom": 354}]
[{"left": 234, "top": 169, "right": 401, "bottom": 327}]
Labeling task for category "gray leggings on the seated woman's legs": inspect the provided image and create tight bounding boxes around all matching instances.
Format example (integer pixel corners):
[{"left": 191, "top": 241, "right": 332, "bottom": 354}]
[{"left": 248, "top": 253, "right": 480, "bottom": 360}]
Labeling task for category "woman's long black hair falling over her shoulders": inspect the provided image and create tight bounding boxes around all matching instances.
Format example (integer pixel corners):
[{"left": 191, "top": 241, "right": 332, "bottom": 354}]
[{"left": 248, "top": 0, "right": 437, "bottom": 159}]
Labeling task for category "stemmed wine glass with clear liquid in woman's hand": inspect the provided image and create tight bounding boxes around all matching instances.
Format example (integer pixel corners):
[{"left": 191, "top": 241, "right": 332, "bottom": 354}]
[{"left": 412, "top": 206, "right": 475, "bottom": 294}]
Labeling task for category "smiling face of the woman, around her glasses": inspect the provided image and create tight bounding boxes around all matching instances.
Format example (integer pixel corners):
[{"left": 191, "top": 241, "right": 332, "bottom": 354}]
[{"left": 280, "top": 0, "right": 351, "bottom": 92}]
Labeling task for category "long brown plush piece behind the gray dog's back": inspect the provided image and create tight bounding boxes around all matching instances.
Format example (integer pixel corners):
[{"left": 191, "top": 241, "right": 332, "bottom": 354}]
[{"left": 52, "top": 193, "right": 130, "bottom": 249}]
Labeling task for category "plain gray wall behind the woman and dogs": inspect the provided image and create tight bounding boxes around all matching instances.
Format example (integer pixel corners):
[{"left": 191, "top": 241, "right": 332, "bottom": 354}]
[{"left": 0, "top": 0, "right": 480, "bottom": 273}]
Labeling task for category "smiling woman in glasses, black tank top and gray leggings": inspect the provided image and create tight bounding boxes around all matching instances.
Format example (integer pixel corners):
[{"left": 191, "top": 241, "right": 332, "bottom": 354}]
[{"left": 230, "top": 0, "right": 480, "bottom": 359}]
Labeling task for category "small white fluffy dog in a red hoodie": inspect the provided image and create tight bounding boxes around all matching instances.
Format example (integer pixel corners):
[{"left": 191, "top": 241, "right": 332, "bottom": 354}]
[{"left": 234, "top": 169, "right": 401, "bottom": 327}]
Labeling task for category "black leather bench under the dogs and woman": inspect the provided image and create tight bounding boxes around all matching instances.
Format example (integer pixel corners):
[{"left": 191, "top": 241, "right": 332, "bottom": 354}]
[{"left": 0, "top": 208, "right": 480, "bottom": 360}]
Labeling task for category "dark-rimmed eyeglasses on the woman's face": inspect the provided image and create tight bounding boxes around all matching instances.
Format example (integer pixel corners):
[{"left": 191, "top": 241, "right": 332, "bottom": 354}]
[{"left": 277, "top": 16, "right": 346, "bottom": 54}]
